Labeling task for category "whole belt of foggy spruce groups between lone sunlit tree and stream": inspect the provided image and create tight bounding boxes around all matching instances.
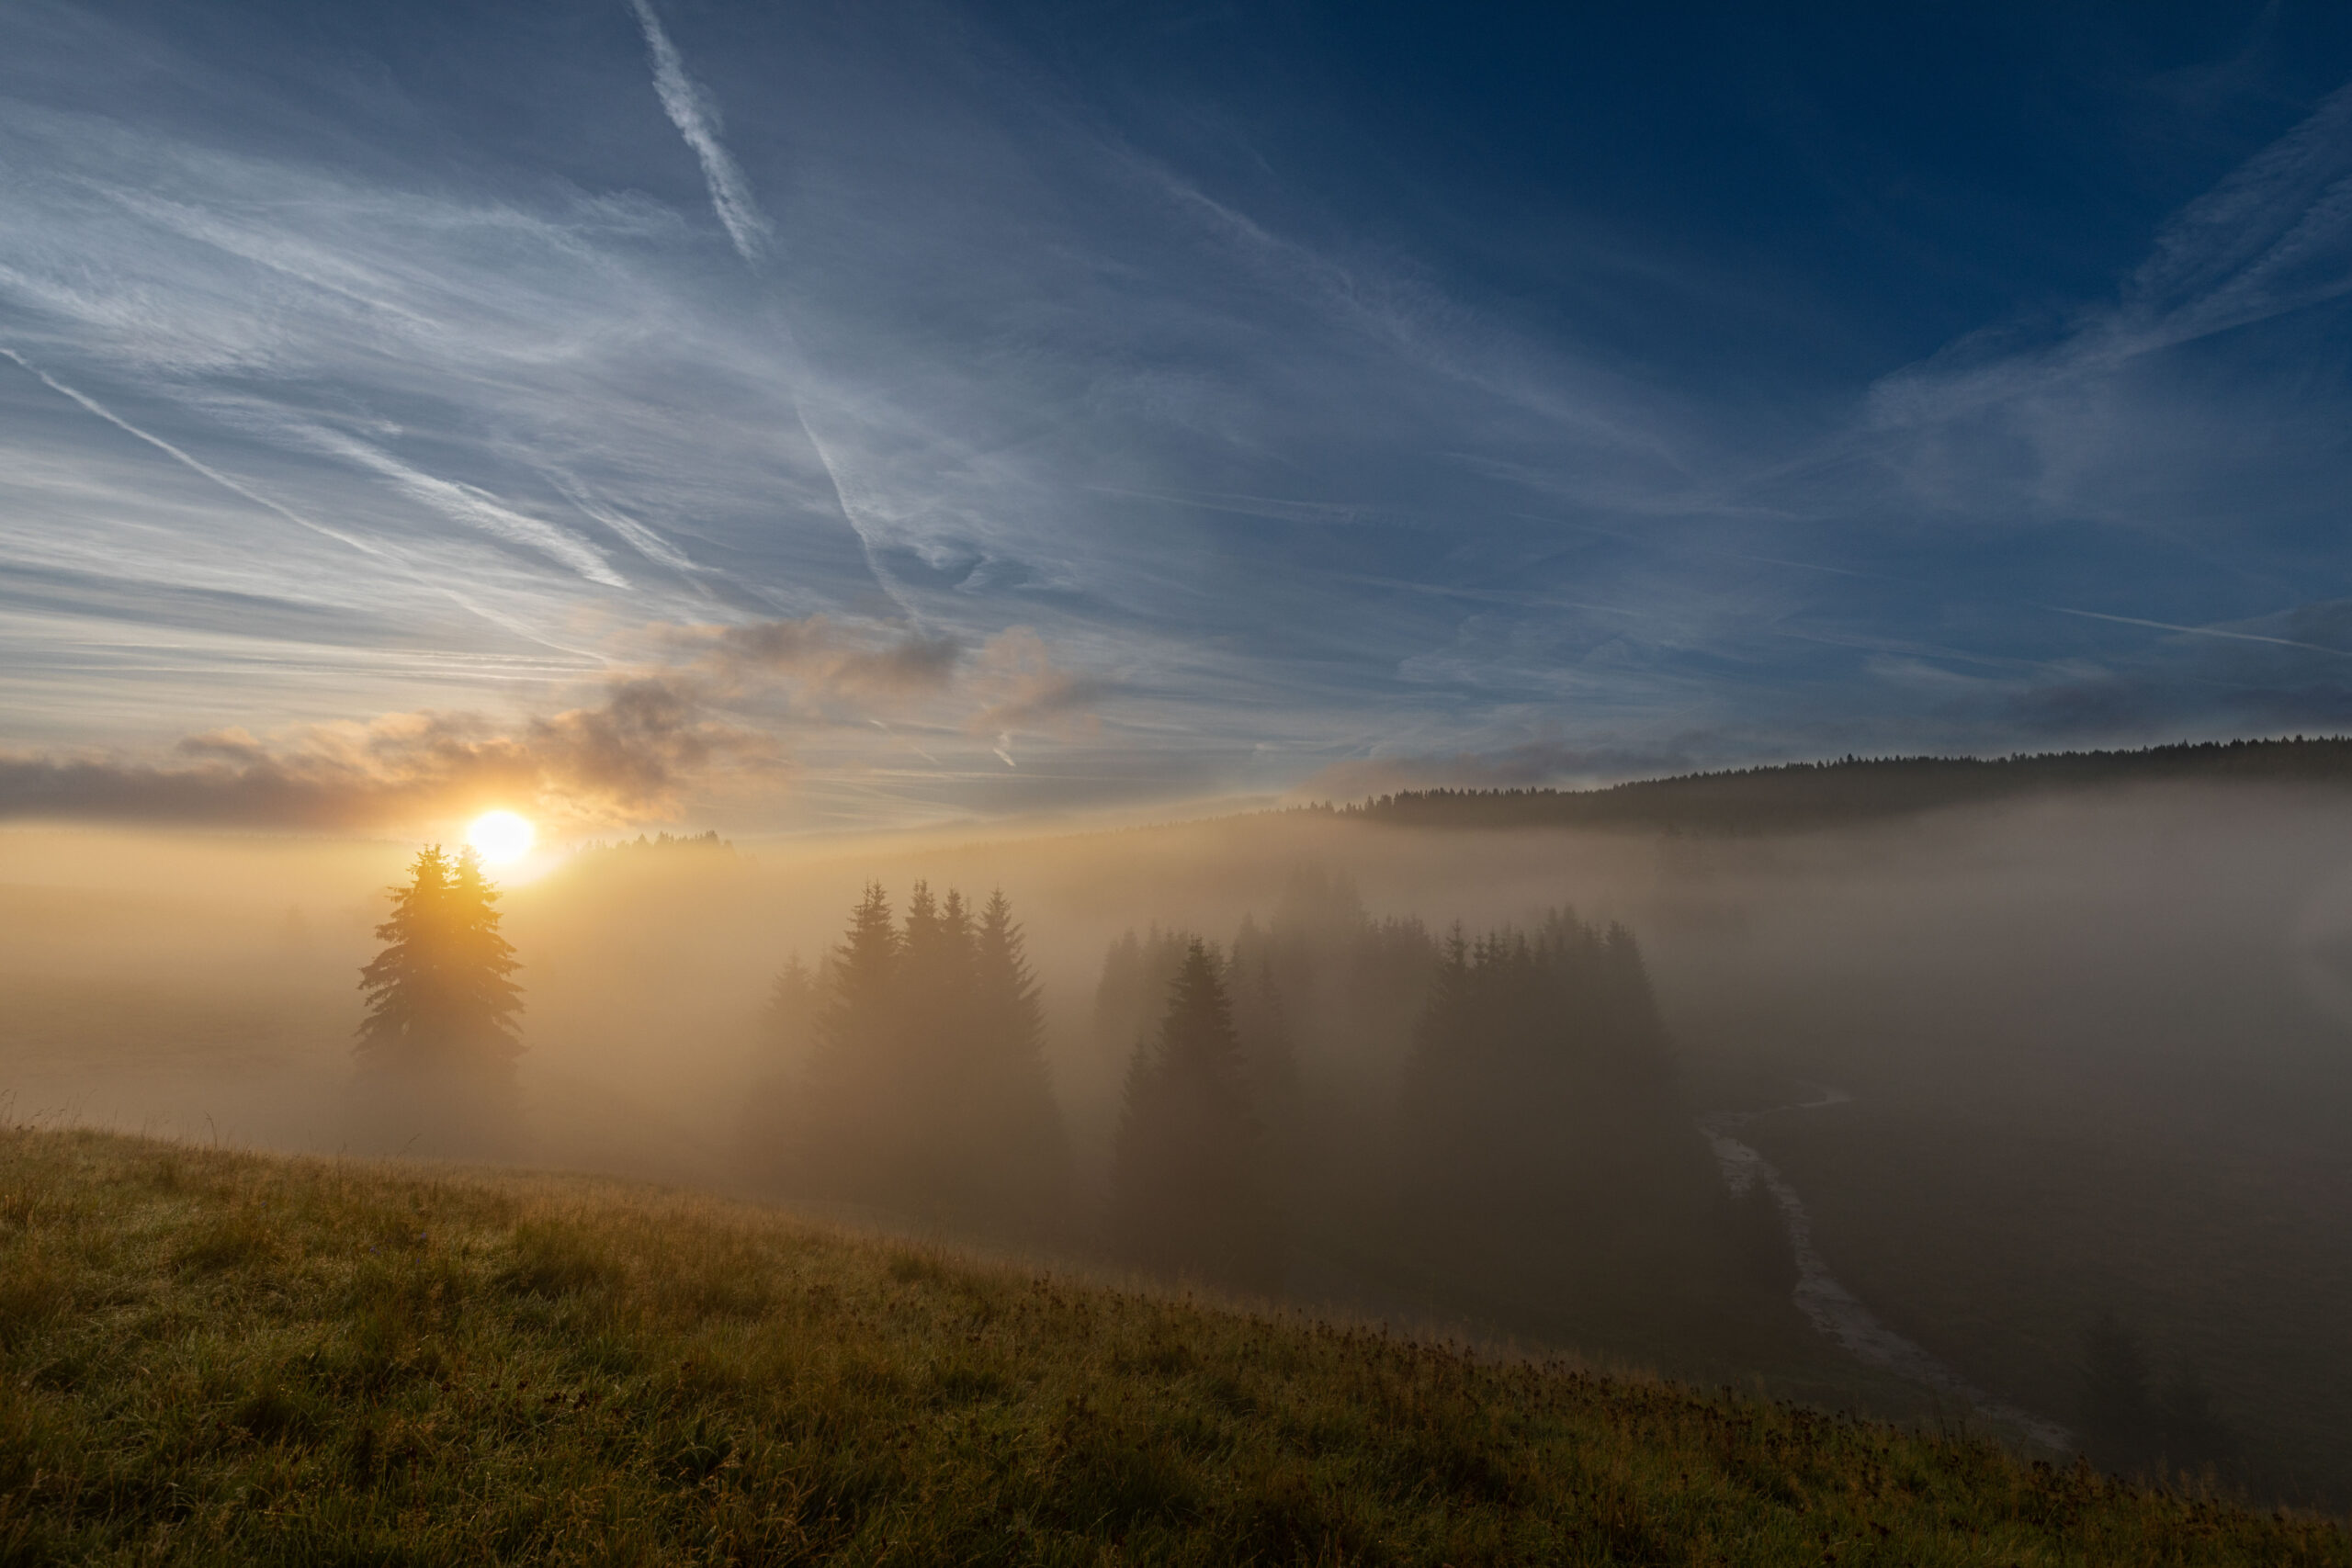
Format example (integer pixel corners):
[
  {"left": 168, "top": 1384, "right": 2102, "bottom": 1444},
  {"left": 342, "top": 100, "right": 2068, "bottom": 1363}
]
[{"left": 743, "top": 867, "right": 1790, "bottom": 1342}]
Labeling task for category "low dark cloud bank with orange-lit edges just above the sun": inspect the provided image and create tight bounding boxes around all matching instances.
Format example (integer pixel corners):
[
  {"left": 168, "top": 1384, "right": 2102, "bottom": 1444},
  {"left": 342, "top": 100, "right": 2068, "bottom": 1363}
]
[{"left": 0, "top": 616, "right": 1119, "bottom": 829}]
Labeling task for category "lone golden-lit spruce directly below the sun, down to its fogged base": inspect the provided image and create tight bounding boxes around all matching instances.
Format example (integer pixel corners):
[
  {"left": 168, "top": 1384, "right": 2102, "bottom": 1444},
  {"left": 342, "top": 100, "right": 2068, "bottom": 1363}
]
[{"left": 357, "top": 844, "right": 522, "bottom": 1155}]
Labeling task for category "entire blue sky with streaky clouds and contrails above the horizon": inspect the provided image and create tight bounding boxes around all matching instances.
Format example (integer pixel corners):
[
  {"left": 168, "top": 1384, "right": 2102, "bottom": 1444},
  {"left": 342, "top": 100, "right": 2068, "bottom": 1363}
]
[{"left": 0, "top": 0, "right": 2352, "bottom": 832}]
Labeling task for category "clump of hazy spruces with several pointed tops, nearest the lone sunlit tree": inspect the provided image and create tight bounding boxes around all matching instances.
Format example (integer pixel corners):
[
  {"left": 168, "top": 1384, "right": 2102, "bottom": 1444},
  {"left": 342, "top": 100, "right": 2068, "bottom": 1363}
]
[{"left": 751, "top": 882, "right": 1070, "bottom": 1229}]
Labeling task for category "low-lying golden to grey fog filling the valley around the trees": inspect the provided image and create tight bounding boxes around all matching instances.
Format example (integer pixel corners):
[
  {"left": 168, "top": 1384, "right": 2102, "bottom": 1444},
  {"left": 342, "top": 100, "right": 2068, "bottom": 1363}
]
[{"left": 0, "top": 787, "right": 2352, "bottom": 1505}]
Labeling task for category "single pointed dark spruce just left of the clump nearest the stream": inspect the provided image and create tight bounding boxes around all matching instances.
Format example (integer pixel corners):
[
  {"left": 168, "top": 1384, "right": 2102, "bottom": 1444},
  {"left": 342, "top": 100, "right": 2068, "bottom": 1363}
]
[{"left": 1113, "top": 941, "right": 1282, "bottom": 1291}]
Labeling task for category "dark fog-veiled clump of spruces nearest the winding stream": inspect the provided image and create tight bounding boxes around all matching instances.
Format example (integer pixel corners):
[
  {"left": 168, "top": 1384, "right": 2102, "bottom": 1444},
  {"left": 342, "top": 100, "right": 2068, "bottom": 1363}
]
[{"left": 1397, "top": 909, "right": 1792, "bottom": 1342}]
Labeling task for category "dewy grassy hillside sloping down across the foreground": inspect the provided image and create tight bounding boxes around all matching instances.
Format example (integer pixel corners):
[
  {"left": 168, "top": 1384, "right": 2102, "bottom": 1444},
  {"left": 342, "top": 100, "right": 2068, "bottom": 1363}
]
[{"left": 0, "top": 1131, "right": 2352, "bottom": 1563}]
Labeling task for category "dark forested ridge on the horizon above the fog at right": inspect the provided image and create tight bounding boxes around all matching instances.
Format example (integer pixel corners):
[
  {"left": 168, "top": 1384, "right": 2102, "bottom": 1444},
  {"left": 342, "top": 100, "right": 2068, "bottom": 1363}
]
[{"left": 1301, "top": 736, "right": 2352, "bottom": 835}]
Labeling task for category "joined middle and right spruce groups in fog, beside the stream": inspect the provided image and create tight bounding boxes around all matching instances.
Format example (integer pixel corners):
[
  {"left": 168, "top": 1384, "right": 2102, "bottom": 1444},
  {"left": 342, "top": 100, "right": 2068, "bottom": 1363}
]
[{"left": 1096, "top": 870, "right": 1792, "bottom": 1342}]
